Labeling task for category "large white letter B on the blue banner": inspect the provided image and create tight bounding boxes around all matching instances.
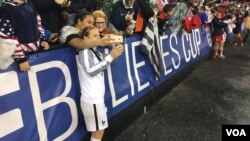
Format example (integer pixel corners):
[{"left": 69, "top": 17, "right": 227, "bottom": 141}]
[{"left": 28, "top": 61, "right": 78, "bottom": 141}]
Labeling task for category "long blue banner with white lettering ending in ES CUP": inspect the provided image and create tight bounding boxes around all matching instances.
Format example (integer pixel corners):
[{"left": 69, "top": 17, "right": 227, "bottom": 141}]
[{"left": 0, "top": 27, "right": 212, "bottom": 141}]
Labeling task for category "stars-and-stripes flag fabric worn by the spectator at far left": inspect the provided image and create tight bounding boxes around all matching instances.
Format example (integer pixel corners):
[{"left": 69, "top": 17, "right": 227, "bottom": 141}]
[{"left": 0, "top": 0, "right": 44, "bottom": 58}]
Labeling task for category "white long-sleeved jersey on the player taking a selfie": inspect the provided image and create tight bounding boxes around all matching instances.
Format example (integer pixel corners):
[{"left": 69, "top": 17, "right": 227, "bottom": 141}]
[{"left": 77, "top": 49, "right": 113, "bottom": 104}]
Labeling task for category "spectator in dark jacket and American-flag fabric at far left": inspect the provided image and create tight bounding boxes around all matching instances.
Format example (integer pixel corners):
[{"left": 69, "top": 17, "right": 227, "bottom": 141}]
[{"left": 0, "top": 0, "right": 49, "bottom": 71}]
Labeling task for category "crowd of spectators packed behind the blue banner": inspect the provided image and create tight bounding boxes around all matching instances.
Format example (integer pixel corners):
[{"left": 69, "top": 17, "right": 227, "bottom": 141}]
[{"left": 0, "top": 0, "right": 249, "bottom": 69}]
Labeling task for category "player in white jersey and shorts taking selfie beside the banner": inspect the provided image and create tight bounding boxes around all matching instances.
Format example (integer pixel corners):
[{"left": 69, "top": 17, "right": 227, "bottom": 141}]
[{"left": 77, "top": 27, "right": 123, "bottom": 141}]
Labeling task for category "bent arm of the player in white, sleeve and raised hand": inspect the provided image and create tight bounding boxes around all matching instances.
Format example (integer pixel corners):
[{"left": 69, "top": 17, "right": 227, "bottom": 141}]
[{"left": 79, "top": 45, "right": 123, "bottom": 77}]
